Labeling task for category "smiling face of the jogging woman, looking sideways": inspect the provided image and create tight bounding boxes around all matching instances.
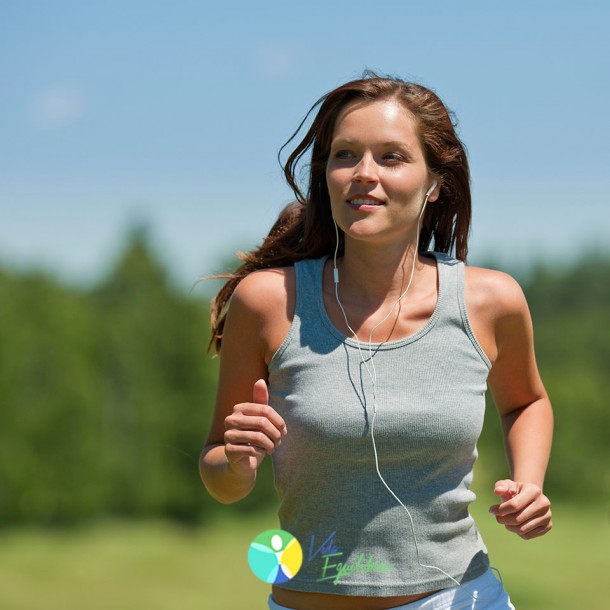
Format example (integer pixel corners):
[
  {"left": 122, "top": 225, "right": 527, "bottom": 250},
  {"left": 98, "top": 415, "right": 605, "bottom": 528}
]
[{"left": 326, "top": 100, "right": 438, "bottom": 244}]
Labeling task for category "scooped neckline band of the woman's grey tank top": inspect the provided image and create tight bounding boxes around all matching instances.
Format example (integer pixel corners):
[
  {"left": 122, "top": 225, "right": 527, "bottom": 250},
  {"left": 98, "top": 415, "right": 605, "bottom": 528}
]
[{"left": 312, "top": 252, "right": 447, "bottom": 351}]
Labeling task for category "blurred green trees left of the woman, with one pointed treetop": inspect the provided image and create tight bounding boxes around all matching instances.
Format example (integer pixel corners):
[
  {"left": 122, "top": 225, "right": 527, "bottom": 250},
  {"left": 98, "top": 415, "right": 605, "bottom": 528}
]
[{"left": 0, "top": 226, "right": 216, "bottom": 525}]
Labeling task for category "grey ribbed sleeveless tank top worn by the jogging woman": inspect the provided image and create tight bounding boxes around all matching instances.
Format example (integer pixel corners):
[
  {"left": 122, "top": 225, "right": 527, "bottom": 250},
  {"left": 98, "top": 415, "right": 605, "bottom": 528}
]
[{"left": 269, "top": 253, "right": 491, "bottom": 597}]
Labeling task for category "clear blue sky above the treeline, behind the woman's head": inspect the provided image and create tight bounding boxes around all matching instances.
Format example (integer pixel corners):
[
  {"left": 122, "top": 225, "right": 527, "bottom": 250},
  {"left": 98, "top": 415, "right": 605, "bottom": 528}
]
[{"left": 0, "top": 0, "right": 610, "bottom": 285}]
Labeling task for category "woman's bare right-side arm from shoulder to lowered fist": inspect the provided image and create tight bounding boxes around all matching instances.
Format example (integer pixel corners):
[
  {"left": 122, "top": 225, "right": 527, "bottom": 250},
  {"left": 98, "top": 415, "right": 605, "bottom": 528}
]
[{"left": 467, "top": 270, "right": 553, "bottom": 539}]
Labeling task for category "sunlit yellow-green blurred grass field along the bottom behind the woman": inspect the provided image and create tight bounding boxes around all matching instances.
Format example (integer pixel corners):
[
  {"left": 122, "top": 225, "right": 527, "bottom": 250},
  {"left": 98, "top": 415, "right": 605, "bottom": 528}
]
[{"left": 0, "top": 499, "right": 610, "bottom": 610}]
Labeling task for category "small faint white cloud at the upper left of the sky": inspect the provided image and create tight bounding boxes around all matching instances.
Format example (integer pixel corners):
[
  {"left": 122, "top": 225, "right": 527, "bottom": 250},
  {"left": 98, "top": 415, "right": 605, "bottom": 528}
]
[{"left": 30, "top": 86, "right": 85, "bottom": 129}]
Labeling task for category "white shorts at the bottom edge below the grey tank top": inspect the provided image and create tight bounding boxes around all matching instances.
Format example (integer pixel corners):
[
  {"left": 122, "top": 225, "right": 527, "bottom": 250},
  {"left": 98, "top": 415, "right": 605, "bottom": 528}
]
[{"left": 269, "top": 568, "right": 515, "bottom": 610}]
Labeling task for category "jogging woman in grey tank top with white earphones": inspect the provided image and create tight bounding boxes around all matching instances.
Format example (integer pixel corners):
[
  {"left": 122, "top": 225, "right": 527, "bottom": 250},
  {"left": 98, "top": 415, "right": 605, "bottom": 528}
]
[{"left": 200, "top": 75, "right": 552, "bottom": 610}]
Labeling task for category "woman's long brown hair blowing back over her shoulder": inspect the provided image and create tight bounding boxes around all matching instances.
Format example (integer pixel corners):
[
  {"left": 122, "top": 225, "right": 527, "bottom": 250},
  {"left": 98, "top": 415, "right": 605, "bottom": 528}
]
[{"left": 210, "top": 72, "right": 471, "bottom": 351}]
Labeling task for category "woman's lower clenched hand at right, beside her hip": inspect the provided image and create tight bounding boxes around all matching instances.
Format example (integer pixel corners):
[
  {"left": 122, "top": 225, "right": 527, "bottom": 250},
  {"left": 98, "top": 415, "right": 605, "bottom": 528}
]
[{"left": 489, "top": 479, "right": 553, "bottom": 540}]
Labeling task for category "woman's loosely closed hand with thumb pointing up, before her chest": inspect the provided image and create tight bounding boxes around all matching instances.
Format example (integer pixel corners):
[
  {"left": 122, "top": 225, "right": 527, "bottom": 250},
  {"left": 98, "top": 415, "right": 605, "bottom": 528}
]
[{"left": 224, "top": 379, "right": 286, "bottom": 475}]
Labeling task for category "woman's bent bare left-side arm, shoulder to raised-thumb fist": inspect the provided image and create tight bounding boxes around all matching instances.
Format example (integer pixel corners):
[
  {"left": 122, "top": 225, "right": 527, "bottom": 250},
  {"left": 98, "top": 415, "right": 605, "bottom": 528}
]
[{"left": 199, "top": 270, "right": 292, "bottom": 504}]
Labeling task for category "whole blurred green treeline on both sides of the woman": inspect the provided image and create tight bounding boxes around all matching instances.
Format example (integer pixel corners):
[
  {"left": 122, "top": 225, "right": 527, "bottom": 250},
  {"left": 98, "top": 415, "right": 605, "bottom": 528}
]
[{"left": 0, "top": 232, "right": 610, "bottom": 527}]
